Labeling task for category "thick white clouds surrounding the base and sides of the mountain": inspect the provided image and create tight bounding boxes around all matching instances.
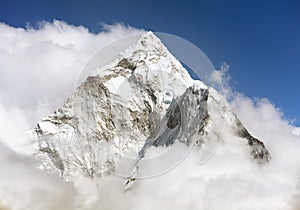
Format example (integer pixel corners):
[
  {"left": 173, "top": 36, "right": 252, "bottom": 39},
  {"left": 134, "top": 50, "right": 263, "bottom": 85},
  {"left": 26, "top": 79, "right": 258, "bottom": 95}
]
[{"left": 0, "top": 21, "right": 300, "bottom": 210}]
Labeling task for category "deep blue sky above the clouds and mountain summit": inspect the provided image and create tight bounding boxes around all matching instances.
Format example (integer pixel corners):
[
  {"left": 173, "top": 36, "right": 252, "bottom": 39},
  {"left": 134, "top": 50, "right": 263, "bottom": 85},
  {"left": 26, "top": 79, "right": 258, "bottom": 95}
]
[{"left": 0, "top": 0, "right": 300, "bottom": 126}]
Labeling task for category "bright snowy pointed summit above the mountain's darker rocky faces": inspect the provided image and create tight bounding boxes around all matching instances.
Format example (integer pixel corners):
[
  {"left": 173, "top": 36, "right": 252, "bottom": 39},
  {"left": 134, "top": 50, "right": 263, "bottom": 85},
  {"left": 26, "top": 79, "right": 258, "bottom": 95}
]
[{"left": 96, "top": 31, "right": 202, "bottom": 95}]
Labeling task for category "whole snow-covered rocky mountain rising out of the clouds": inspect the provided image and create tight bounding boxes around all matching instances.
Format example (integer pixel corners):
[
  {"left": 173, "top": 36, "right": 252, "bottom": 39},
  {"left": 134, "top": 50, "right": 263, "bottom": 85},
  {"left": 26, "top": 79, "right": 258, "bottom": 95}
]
[{"left": 32, "top": 32, "right": 270, "bottom": 189}]
